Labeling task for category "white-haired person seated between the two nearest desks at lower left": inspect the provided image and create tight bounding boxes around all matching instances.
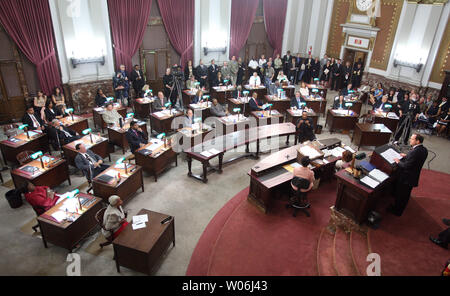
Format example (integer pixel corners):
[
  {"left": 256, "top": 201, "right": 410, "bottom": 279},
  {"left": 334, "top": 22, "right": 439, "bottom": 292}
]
[{"left": 102, "top": 195, "right": 128, "bottom": 239}]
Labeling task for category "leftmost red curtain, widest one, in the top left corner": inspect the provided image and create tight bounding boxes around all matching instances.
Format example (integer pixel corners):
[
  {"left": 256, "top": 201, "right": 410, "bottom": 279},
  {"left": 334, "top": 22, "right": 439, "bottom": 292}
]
[{"left": 0, "top": 0, "right": 61, "bottom": 95}]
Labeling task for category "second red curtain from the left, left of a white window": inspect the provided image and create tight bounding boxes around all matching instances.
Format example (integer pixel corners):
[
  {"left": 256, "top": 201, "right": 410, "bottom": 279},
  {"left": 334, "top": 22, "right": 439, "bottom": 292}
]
[{"left": 108, "top": 0, "right": 152, "bottom": 71}]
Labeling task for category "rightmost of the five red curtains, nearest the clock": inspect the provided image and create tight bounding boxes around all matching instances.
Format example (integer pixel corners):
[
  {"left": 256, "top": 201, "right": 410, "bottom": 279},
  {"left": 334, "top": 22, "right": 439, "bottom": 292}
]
[{"left": 263, "top": 0, "right": 287, "bottom": 56}]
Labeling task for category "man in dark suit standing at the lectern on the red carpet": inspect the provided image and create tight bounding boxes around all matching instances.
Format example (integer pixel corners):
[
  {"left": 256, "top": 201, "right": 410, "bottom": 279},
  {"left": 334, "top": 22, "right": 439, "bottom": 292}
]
[{"left": 387, "top": 134, "right": 428, "bottom": 217}]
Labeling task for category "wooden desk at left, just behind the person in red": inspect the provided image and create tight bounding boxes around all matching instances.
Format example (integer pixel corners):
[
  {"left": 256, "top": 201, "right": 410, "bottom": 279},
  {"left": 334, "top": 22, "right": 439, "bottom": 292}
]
[{"left": 11, "top": 155, "right": 72, "bottom": 189}]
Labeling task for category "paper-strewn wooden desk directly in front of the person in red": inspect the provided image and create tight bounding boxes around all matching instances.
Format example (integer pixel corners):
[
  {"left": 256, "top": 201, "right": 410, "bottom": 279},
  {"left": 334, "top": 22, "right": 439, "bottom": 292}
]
[{"left": 37, "top": 193, "right": 102, "bottom": 253}]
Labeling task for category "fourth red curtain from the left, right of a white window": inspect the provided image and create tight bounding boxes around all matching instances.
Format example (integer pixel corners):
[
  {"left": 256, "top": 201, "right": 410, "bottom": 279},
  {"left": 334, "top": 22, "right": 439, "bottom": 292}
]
[{"left": 230, "top": 0, "right": 259, "bottom": 59}]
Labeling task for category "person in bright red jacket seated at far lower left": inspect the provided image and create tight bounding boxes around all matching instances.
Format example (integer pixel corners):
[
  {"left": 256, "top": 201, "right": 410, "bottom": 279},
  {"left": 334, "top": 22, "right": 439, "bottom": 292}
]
[{"left": 25, "top": 182, "right": 59, "bottom": 215}]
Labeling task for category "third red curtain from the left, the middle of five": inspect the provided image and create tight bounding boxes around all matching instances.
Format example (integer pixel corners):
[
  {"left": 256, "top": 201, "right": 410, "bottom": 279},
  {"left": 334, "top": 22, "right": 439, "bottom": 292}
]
[{"left": 158, "top": 0, "right": 195, "bottom": 68}]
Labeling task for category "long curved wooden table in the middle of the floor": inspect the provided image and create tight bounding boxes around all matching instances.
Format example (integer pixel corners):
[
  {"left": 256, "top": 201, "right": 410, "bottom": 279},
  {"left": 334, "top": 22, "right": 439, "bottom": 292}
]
[{"left": 186, "top": 123, "right": 295, "bottom": 183}]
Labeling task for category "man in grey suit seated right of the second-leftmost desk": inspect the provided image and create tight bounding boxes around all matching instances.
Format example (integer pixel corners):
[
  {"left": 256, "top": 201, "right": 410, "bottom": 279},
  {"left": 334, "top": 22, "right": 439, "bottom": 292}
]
[{"left": 75, "top": 144, "right": 108, "bottom": 179}]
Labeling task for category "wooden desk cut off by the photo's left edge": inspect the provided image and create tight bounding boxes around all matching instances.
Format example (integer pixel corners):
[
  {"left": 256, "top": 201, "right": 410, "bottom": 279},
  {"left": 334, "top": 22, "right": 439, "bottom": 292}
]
[{"left": 0, "top": 131, "right": 49, "bottom": 165}]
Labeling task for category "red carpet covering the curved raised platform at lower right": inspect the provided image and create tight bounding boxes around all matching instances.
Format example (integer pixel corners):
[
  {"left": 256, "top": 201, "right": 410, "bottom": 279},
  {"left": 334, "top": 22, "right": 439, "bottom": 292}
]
[{"left": 186, "top": 170, "right": 450, "bottom": 276}]
